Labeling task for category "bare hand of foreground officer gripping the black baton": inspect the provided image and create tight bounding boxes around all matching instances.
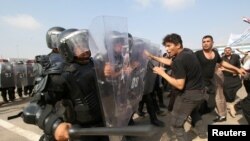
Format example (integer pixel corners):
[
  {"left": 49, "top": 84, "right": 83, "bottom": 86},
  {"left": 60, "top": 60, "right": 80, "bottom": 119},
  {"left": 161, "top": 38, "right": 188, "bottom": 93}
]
[{"left": 54, "top": 122, "right": 71, "bottom": 141}]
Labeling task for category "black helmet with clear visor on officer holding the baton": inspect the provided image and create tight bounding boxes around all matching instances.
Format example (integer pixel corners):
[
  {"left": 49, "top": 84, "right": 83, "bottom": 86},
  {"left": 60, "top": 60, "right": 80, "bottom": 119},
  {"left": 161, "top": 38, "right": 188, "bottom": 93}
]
[{"left": 59, "top": 29, "right": 91, "bottom": 63}]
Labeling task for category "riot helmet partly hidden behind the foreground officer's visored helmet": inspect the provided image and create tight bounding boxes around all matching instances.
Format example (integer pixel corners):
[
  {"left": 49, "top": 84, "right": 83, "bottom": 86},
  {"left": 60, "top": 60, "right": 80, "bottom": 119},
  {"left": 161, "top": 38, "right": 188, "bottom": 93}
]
[{"left": 46, "top": 26, "right": 65, "bottom": 49}]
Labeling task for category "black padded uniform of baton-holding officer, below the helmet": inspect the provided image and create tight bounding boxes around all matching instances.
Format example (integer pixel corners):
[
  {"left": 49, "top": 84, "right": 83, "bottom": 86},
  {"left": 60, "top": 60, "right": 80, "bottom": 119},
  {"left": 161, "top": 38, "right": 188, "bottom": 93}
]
[{"left": 22, "top": 61, "right": 103, "bottom": 140}]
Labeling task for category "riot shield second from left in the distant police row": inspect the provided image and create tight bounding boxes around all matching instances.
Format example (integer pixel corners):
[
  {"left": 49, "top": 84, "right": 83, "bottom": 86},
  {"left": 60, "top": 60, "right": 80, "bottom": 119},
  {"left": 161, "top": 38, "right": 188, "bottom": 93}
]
[{"left": 13, "top": 63, "right": 28, "bottom": 88}]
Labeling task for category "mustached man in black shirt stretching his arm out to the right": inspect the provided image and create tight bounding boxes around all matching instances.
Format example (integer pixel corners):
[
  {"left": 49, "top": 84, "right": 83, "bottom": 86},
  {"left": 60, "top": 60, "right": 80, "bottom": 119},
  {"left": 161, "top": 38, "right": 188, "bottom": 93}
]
[{"left": 194, "top": 35, "right": 246, "bottom": 123}]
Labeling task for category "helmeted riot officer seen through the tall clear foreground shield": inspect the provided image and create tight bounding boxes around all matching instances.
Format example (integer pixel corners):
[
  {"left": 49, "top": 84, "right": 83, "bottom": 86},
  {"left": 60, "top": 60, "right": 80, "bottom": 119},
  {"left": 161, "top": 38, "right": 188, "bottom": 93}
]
[{"left": 93, "top": 30, "right": 131, "bottom": 127}]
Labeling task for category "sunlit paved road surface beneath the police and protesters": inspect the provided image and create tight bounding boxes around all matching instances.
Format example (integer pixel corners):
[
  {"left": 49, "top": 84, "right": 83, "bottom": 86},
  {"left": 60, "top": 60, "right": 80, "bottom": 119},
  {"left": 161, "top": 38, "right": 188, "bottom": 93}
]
[{"left": 0, "top": 88, "right": 247, "bottom": 141}]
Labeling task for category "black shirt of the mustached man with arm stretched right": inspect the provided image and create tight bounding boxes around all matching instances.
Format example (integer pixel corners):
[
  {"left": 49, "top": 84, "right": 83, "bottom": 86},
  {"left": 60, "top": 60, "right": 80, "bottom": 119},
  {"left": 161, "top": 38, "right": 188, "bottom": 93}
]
[{"left": 195, "top": 50, "right": 222, "bottom": 79}]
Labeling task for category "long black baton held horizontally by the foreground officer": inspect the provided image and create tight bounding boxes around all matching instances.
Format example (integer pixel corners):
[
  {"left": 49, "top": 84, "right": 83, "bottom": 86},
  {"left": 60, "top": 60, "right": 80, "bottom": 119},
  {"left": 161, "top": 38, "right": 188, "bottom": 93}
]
[{"left": 69, "top": 125, "right": 157, "bottom": 138}]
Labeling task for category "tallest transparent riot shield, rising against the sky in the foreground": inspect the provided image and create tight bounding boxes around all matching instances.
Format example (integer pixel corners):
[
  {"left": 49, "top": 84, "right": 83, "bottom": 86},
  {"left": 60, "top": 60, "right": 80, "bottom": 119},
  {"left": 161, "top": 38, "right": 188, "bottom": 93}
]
[{"left": 89, "top": 17, "right": 133, "bottom": 141}]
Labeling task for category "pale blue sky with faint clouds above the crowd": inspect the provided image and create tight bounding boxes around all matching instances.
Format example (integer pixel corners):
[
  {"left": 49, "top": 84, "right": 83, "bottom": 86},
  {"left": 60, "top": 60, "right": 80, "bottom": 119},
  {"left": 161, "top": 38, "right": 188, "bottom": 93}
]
[{"left": 0, "top": 0, "right": 250, "bottom": 59}]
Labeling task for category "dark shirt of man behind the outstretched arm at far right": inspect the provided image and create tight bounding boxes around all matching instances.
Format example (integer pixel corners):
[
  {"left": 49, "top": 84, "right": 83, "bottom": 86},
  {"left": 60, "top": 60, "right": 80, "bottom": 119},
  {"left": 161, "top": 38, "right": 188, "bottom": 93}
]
[{"left": 222, "top": 54, "right": 240, "bottom": 76}]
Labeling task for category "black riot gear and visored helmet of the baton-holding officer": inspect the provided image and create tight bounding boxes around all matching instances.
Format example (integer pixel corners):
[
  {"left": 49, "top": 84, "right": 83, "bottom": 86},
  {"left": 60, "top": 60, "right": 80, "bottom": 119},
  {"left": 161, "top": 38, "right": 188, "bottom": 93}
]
[{"left": 23, "top": 29, "right": 108, "bottom": 141}]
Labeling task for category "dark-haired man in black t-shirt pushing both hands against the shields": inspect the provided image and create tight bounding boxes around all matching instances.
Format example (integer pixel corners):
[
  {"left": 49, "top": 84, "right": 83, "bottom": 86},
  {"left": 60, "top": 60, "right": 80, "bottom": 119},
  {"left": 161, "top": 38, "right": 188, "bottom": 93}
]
[{"left": 145, "top": 34, "right": 205, "bottom": 141}]
